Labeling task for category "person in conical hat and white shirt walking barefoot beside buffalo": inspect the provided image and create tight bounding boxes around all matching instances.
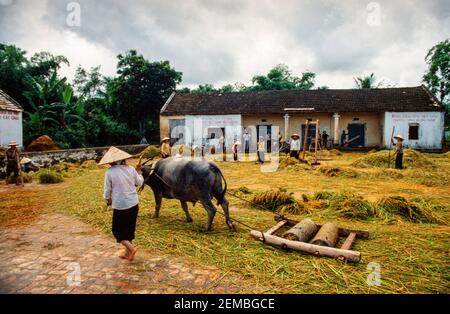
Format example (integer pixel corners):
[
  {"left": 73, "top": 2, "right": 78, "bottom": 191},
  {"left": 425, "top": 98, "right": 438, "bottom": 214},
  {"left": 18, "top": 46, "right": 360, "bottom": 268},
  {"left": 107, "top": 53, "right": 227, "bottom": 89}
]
[{"left": 99, "top": 147, "right": 144, "bottom": 262}]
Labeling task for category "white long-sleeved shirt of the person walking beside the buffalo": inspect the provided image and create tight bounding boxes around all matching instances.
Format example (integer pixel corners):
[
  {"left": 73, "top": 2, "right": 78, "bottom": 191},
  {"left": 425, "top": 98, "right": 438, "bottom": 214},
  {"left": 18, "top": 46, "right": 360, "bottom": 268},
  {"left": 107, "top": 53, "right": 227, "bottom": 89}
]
[{"left": 103, "top": 165, "right": 144, "bottom": 209}]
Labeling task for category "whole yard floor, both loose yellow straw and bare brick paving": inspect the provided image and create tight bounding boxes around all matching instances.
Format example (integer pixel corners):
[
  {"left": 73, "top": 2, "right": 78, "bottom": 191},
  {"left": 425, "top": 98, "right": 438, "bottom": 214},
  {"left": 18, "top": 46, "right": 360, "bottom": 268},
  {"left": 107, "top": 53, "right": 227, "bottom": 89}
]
[{"left": 0, "top": 153, "right": 450, "bottom": 293}]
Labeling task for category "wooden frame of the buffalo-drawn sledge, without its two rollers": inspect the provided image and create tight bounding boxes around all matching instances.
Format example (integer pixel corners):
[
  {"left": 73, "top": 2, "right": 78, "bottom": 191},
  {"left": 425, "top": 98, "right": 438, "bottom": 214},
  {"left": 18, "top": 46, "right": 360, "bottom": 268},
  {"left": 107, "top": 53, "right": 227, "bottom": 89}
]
[{"left": 250, "top": 215, "right": 369, "bottom": 263}]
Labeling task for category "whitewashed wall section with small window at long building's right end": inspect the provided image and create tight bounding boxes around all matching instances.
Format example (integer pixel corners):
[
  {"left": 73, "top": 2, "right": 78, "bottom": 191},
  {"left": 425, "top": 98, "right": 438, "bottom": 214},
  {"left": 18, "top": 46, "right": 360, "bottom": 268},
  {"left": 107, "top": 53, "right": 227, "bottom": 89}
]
[{"left": 384, "top": 112, "right": 444, "bottom": 149}]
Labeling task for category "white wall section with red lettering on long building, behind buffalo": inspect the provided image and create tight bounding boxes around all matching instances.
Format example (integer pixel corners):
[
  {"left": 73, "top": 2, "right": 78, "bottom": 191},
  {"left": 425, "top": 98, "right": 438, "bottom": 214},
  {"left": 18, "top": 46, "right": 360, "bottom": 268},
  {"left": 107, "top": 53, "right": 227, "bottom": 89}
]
[{"left": 185, "top": 115, "right": 242, "bottom": 146}]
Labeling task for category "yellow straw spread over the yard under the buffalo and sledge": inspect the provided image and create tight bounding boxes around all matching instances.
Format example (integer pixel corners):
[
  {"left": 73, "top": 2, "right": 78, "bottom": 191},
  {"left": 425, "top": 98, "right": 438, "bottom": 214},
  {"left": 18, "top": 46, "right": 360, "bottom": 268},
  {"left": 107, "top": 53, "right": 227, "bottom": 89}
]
[{"left": 25, "top": 153, "right": 450, "bottom": 293}]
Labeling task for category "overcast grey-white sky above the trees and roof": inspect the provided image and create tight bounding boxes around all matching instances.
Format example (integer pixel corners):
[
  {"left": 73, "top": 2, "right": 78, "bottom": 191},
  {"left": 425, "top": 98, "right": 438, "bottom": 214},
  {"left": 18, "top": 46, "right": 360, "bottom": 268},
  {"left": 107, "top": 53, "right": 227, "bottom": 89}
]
[{"left": 0, "top": 0, "right": 450, "bottom": 88}]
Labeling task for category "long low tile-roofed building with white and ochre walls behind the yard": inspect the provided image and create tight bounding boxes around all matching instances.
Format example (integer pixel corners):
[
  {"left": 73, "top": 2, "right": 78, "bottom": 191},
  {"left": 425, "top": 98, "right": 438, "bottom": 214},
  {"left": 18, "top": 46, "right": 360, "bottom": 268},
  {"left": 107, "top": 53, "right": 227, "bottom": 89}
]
[{"left": 160, "top": 86, "right": 445, "bottom": 150}]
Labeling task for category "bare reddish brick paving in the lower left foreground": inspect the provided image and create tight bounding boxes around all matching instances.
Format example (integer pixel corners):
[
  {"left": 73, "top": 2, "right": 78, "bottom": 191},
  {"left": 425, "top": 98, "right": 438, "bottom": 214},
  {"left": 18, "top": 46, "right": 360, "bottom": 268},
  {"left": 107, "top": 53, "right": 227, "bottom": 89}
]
[{"left": 0, "top": 213, "right": 243, "bottom": 294}]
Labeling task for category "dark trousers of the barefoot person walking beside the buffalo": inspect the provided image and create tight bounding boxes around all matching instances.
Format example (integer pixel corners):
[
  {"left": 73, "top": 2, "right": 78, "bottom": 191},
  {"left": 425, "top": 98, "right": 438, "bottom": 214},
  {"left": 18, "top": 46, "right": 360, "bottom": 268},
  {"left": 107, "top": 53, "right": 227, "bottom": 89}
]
[{"left": 112, "top": 205, "right": 139, "bottom": 243}]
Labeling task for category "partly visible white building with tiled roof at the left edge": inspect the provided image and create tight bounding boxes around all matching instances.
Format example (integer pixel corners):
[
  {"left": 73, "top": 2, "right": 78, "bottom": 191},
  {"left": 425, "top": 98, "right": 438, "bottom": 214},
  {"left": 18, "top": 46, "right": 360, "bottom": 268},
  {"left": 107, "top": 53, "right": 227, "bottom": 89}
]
[{"left": 0, "top": 89, "right": 23, "bottom": 147}]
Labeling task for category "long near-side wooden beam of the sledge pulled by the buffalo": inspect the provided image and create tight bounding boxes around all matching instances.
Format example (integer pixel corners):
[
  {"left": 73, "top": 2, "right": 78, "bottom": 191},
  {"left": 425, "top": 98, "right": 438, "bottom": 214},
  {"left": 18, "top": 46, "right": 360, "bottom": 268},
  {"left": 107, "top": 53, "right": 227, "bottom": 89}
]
[{"left": 250, "top": 230, "right": 361, "bottom": 263}]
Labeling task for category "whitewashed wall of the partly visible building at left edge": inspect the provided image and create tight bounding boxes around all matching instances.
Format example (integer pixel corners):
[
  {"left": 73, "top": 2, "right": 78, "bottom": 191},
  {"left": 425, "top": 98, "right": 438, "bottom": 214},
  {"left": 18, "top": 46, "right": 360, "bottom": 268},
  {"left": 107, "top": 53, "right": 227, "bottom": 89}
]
[{"left": 0, "top": 110, "right": 23, "bottom": 147}]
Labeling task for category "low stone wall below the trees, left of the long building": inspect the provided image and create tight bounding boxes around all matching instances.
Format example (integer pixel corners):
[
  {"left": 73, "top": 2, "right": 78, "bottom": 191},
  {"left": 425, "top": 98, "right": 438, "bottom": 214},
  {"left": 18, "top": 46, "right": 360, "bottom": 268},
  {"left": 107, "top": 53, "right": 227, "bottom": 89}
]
[{"left": 0, "top": 145, "right": 148, "bottom": 177}]
